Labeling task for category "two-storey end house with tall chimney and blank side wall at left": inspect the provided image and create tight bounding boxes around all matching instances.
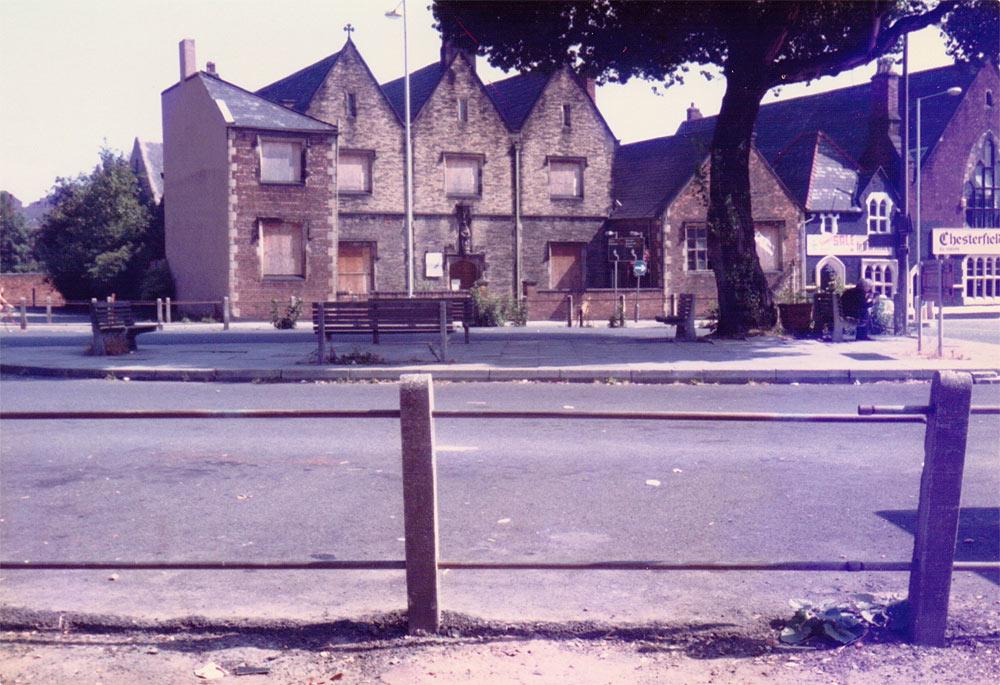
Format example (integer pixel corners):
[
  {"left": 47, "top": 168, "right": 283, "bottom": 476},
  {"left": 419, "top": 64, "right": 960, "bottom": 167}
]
[{"left": 162, "top": 41, "right": 337, "bottom": 318}]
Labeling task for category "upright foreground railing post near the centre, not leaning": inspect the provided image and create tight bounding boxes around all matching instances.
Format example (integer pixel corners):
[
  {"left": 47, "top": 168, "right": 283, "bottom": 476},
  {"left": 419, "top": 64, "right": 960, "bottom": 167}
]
[{"left": 399, "top": 374, "right": 441, "bottom": 634}]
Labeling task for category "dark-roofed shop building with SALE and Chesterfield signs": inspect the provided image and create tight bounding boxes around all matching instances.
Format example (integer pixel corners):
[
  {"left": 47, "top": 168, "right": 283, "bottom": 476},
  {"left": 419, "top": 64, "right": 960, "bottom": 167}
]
[{"left": 678, "top": 61, "right": 1000, "bottom": 305}]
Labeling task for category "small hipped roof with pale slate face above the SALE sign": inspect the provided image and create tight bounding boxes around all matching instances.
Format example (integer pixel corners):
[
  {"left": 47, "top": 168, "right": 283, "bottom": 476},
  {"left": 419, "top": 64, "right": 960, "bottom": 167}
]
[{"left": 773, "top": 131, "right": 860, "bottom": 212}]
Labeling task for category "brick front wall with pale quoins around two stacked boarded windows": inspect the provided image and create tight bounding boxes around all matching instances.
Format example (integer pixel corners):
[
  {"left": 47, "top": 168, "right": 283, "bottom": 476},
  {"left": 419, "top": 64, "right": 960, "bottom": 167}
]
[{"left": 229, "top": 129, "right": 337, "bottom": 318}]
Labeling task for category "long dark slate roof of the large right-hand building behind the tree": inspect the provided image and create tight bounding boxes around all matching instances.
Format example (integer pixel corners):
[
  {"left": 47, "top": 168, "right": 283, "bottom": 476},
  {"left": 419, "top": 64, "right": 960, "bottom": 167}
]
[{"left": 678, "top": 64, "right": 978, "bottom": 168}]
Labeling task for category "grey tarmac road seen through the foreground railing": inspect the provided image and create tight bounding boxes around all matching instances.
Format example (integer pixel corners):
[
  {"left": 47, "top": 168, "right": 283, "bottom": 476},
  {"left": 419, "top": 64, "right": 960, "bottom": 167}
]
[{"left": 0, "top": 378, "right": 1000, "bottom": 622}]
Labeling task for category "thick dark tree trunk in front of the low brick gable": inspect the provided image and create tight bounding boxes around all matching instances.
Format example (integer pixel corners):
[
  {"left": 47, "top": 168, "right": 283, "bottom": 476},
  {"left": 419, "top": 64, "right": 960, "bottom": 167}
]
[{"left": 708, "top": 66, "right": 777, "bottom": 338}]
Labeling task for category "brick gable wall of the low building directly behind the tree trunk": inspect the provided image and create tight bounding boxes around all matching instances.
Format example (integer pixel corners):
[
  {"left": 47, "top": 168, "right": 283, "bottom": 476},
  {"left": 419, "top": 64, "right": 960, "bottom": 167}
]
[{"left": 663, "top": 151, "right": 802, "bottom": 315}]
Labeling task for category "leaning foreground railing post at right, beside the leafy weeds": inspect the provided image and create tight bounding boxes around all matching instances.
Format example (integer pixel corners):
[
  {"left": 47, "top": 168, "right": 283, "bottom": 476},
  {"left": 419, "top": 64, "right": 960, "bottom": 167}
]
[{"left": 909, "top": 371, "right": 972, "bottom": 647}]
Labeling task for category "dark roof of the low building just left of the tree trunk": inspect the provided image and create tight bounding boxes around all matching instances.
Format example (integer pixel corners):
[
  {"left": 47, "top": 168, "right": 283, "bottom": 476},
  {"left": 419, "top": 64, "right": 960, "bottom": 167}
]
[{"left": 611, "top": 135, "right": 708, "bottom": 219}]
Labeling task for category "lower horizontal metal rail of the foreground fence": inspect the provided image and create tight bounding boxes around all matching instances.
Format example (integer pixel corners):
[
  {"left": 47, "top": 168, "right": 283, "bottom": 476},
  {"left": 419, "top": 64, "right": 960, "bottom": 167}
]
[{"left": 0, "top": 559, "right": 1000, "bottom": 573}]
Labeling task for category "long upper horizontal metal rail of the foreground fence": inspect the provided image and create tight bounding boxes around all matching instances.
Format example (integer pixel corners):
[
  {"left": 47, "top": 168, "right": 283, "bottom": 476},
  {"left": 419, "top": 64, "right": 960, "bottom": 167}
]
[{"left": 0, "top": 409, "right": 924, "bottom": 423}]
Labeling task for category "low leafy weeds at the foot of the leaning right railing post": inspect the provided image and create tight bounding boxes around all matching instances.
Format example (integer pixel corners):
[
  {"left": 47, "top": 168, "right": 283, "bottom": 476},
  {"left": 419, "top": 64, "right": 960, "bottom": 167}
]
[{"left": 780, "top": 594, "right": 890, "bottom": 645}]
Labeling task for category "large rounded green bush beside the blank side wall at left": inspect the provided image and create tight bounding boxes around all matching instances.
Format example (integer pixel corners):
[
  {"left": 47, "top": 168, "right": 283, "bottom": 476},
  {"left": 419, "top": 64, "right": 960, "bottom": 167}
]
[{"left": 38, "top": 148, "right": 163, "bottom": 300}]
